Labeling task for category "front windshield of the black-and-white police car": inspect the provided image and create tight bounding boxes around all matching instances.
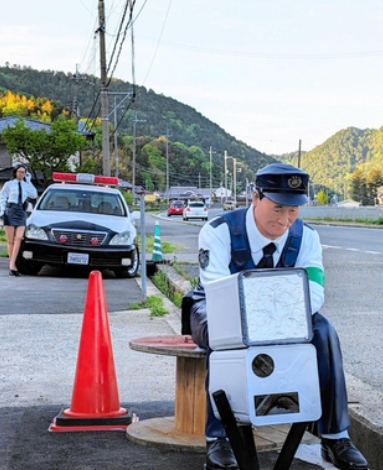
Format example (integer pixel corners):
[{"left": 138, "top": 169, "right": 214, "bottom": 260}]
[{"left": 37, "top": 188, "right": 127, "bottom": 217}]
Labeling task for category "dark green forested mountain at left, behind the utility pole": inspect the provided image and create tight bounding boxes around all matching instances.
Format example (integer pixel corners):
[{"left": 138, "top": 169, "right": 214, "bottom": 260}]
[{"left": 0, "top": 64, "right": 275, "bottom": 186}]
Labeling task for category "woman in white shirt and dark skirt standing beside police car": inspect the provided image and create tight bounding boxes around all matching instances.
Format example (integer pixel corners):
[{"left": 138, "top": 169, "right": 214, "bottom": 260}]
[{"left": 0, "top": 163, "right": 37, "bottom": 276}]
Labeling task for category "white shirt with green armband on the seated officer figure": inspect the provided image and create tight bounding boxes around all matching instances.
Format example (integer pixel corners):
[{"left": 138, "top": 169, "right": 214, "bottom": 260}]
[{"left": 199, "top": 205, "right": 324, "bottom": 313}]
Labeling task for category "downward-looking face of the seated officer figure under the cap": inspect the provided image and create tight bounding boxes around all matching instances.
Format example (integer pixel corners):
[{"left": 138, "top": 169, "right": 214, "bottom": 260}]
[{"left": 253, "top": 194, "right": 299, "bottom": 240}]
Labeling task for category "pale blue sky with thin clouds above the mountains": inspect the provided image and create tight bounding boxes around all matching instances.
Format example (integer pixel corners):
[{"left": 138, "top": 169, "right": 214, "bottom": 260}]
[{"left": 0, "top": 0, "right": 383, "bottom": 154}]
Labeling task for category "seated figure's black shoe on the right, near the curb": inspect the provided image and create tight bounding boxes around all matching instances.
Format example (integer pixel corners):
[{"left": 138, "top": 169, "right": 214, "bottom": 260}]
[{"left": 322, "top": 439, "right": 368, "bottom": 470}]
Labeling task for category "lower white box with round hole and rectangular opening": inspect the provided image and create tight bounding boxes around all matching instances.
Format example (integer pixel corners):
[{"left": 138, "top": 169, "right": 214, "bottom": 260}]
[{"left": 209, "top": 344, "right": 322, "bottom": 426}]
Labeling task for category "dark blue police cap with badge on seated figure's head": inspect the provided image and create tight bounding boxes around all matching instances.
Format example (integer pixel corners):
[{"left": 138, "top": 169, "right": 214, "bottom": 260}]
[{"left": 255, "top": 163, "right": 309, "bottom": 206}]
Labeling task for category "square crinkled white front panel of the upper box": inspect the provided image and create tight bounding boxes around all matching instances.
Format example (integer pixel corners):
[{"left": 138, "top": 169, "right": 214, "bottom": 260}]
[{"left": 242, "top": 270, "right": 311, "bottom": 345}]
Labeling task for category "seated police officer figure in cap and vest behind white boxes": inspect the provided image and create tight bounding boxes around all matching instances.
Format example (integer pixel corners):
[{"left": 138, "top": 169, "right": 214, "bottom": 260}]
[{"left": 190, "top": 163, "right": 368, "bottom": 470}]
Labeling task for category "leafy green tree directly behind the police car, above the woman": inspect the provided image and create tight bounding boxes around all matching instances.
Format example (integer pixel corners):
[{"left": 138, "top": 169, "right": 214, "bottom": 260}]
[{"left": 2, "top": 116, "right": 85, "bottom": 184}]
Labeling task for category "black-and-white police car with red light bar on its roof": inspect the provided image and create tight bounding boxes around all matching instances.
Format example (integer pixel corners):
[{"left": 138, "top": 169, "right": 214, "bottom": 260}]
[{"left": 17, "top": 173, "right": 139, "bottom": 277}]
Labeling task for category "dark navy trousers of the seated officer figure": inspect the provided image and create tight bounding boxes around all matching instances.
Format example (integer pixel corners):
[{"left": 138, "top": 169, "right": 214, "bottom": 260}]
[{"left": 190, "top": 299, "right": 350, "bottom": 437}]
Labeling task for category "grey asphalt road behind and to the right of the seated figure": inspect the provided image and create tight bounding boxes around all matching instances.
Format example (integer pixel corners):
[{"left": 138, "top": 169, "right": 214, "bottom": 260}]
[{"left": 147, "top": 211, "right": 383, "bottom": 426}]
